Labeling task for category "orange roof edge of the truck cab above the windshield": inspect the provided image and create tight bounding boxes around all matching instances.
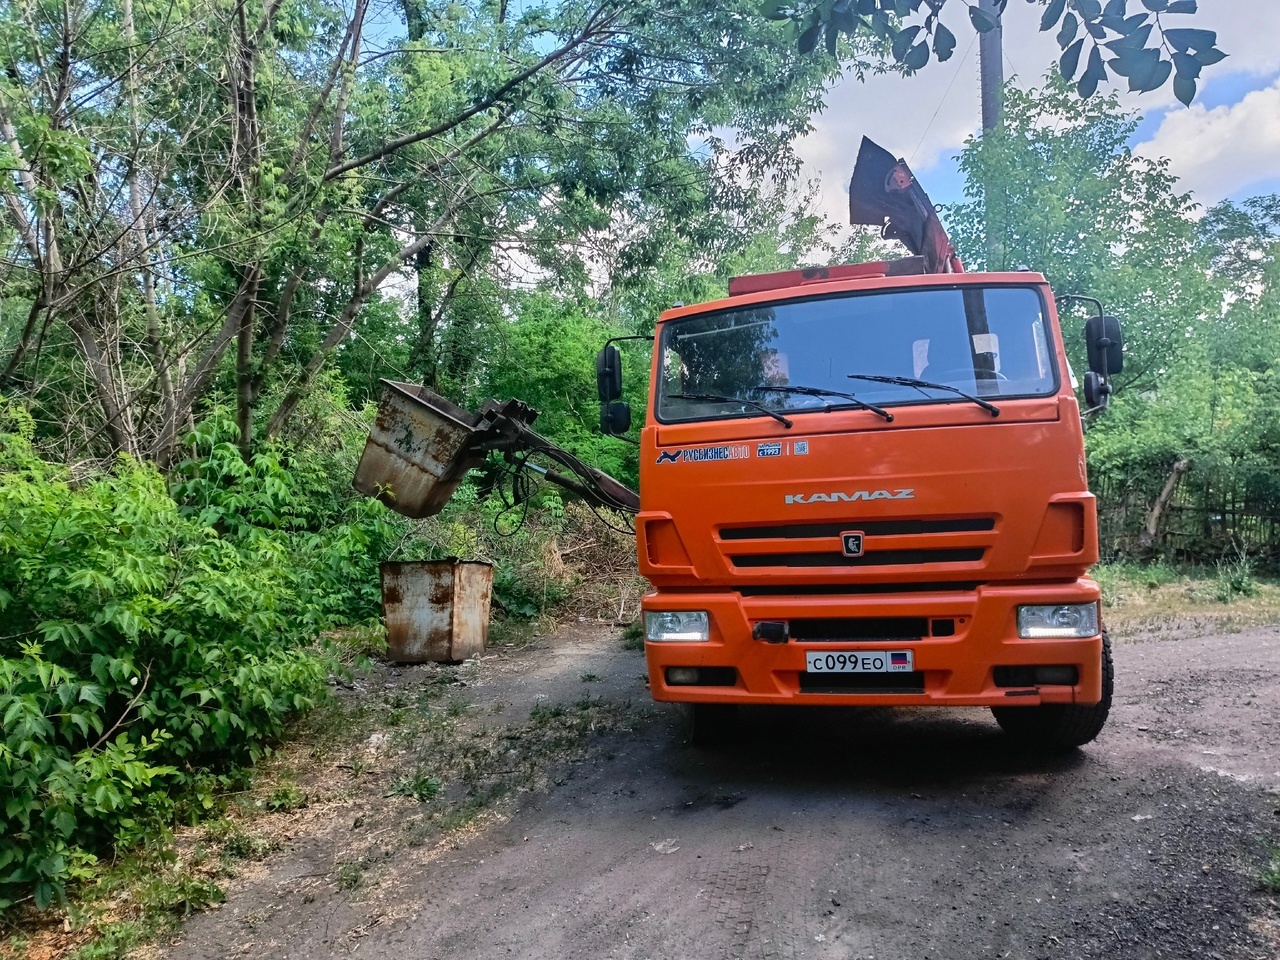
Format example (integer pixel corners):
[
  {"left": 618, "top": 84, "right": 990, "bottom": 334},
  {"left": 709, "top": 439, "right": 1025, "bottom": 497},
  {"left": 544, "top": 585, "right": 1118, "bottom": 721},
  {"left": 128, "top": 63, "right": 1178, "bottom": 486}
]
[{"left": 658, "top": 264, "right": 1047, "bottom": 324}]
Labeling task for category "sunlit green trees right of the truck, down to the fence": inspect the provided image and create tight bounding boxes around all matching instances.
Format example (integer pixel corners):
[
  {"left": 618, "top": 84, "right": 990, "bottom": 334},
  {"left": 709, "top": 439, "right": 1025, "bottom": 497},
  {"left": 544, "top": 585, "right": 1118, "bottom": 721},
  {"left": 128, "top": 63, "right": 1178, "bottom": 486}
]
[{"left": 945, "top": 78, "right": 1280, "bottom": 562}]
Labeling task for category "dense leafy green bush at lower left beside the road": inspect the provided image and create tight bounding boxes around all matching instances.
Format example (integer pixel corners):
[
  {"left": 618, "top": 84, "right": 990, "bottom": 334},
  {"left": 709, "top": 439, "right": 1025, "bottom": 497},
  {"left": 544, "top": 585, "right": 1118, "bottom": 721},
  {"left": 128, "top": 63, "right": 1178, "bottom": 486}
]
[{"left": 0, "top": 407, "right": 397, "bottom": 910}]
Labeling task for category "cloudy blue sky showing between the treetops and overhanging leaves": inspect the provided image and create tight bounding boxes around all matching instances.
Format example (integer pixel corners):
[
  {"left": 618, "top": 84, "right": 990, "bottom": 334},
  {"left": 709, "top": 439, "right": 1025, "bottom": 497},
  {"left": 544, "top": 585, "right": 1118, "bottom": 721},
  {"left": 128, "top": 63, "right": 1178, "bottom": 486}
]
[{"left": 800, "top": 0, "right": 1280, "bottom": 223}]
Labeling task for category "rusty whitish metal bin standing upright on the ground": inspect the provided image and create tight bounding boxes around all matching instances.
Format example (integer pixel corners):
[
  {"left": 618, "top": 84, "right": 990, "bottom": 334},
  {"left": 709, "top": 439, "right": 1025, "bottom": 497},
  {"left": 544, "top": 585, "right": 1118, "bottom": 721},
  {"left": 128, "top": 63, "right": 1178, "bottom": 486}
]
[{"left": 381, "top": 558, "right": 493, "bottom": 663}]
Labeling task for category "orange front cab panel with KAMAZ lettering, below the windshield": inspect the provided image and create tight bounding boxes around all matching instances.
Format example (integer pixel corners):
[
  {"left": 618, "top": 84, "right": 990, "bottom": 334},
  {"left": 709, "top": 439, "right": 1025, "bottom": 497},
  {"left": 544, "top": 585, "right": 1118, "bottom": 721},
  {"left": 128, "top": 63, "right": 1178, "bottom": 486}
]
[{"left": 636, "top": 390, "right": 1098, "bottom": 591}]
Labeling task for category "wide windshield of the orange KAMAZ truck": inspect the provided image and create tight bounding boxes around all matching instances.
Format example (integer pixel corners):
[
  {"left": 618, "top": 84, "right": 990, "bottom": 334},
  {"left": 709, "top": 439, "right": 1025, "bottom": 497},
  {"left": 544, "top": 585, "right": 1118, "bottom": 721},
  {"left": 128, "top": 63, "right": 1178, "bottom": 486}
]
[{"left": 657, "top": 287, "right": 1057, "bottom": 422}]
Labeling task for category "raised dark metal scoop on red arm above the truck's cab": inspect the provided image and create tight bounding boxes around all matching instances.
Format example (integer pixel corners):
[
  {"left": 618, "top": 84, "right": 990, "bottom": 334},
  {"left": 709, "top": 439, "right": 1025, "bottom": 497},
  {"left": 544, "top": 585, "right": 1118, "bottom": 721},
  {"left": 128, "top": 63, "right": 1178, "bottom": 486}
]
[{"left": 849, "top": 137, "right": 964, "bottom": 274}]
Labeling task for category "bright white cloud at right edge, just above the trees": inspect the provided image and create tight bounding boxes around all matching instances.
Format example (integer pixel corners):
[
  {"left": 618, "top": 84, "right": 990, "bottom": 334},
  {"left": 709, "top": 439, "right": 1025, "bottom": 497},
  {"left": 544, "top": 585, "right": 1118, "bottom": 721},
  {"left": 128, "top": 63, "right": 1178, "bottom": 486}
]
[{"left": 1137, "top": 79, "right": 1280, "bottom": 202}]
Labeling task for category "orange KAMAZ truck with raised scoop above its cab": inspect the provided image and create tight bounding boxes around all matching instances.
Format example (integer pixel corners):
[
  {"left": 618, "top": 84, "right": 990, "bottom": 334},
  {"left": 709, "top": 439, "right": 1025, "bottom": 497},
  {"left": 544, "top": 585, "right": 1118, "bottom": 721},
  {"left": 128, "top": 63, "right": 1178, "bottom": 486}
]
[{"left": 598, "top": 136, "right": 1123, "bottom": 748}]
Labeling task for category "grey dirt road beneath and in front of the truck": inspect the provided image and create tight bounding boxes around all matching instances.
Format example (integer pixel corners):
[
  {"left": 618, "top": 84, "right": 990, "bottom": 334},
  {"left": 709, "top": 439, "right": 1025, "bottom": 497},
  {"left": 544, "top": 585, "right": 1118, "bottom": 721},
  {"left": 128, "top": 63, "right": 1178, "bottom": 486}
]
[{"left": 172, "top": 628, "right": 1280, "bottom": 960}]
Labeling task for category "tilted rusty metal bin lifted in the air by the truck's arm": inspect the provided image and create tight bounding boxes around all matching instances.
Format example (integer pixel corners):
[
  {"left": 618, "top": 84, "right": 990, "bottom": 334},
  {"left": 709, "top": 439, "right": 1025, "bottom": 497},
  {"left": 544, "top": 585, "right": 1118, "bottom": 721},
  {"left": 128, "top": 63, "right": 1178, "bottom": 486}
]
[{"left": 353, "top": 380, "right": 484, "bottom": 517}]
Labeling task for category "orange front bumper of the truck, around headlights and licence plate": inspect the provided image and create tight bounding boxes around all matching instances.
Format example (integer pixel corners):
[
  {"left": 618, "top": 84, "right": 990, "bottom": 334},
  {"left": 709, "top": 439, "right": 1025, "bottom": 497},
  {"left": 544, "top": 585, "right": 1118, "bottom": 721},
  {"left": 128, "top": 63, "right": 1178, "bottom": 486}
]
[{"left": 643, "top": 579, "right": 1102, "bottom": 707}]
